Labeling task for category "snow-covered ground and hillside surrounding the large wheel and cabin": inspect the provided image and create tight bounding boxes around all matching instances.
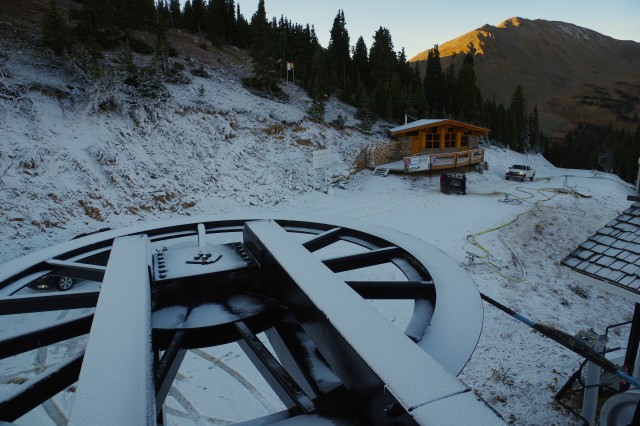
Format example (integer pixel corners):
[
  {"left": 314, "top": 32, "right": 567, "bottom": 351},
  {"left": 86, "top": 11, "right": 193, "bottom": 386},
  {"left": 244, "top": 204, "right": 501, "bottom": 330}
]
[{"left": 0, "top": 41, "right": 633, "bottom": 425}]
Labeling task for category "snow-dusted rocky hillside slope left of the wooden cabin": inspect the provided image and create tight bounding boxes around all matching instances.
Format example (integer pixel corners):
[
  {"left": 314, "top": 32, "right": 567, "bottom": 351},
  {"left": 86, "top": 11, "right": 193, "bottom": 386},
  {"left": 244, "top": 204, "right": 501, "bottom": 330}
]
[{"left": 0, "top": 44, "right": 384, "bottom": 260}]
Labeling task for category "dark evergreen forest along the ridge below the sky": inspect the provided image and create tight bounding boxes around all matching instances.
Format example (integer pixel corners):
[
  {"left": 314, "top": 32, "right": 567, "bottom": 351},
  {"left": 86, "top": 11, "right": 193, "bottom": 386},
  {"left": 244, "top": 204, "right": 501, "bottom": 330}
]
[{"left": 42, "top": 0, "right": 640, "bottom": 180}]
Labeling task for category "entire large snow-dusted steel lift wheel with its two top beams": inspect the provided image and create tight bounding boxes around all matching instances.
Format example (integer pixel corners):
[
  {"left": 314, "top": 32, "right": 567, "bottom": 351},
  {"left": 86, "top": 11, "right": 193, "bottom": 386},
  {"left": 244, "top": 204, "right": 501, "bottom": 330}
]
[{"left": 0, "top": 217, "right": 502, "bottom": 425}]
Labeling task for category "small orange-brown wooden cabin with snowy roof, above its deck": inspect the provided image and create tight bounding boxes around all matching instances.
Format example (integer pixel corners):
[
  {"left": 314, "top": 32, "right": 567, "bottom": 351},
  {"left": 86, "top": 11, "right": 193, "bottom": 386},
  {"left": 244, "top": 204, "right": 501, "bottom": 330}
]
[{"left": 389, "top": 119, "right": 489, "bottom": 155}]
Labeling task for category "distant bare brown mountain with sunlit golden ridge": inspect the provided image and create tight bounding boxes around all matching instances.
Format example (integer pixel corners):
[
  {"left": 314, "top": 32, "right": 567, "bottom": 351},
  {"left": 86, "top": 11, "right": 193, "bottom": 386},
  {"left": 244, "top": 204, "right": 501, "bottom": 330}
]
[{"left": 410, "top": 18, "right": 640, "bottom": 134}]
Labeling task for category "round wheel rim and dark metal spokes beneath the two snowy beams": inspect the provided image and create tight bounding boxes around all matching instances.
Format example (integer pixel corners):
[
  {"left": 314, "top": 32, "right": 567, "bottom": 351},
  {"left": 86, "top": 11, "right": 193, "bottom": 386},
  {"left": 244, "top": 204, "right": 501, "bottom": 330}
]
[{"left": 0, "top": 218, "right": 486, "bottom": 424}]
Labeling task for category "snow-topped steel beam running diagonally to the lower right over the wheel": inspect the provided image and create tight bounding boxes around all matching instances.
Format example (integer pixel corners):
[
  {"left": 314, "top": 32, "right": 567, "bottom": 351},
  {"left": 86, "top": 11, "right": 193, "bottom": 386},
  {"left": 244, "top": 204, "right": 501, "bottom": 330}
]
[{"left": 244, "top": 221, "right": 501, "bottom": 424}]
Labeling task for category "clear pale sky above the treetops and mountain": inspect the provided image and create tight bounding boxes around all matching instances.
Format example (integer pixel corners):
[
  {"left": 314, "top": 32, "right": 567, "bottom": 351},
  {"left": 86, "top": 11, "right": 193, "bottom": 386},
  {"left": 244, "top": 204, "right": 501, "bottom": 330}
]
[{"left": 236, "top": 0, "right": 640, "bottom": 58}]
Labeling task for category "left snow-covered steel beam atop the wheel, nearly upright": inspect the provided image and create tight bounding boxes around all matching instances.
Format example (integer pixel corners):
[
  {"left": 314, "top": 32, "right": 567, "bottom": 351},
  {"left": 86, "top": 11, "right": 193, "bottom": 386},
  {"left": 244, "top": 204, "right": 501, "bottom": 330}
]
[{"left": 69, "top": 235, "right": 155, "bottom": 426}]
